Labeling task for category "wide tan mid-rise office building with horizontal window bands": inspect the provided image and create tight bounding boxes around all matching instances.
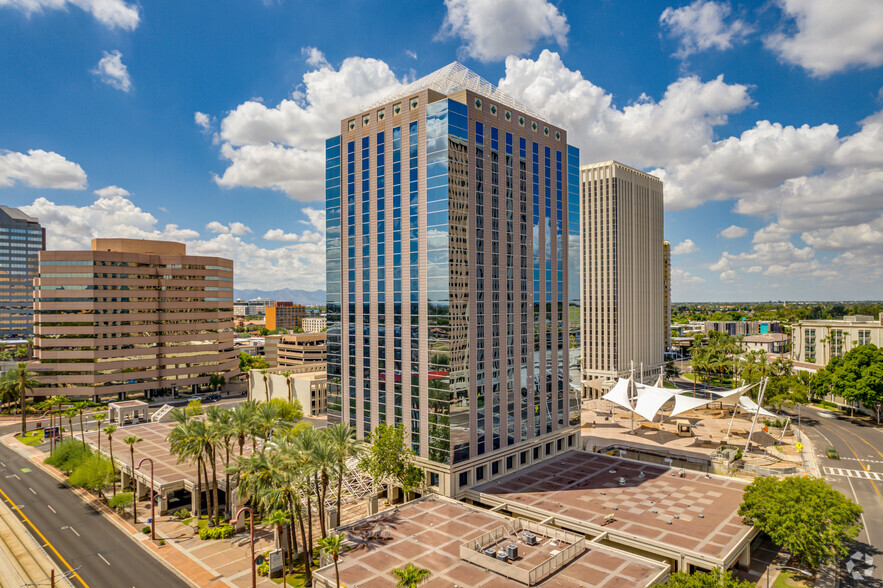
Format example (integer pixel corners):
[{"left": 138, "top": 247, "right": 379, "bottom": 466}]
[{"left": 33, "top": 239, "right": 239, "bottom": 396}]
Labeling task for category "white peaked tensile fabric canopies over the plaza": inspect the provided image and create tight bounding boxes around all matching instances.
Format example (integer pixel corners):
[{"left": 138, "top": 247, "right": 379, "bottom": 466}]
[{"left": 603, "top": 378, "right": 771, "bottom": 421}]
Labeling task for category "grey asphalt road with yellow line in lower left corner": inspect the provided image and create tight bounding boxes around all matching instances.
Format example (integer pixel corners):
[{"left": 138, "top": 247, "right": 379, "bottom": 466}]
[{"left": 0, "top": 445, "right": 186, "bottom": 588}]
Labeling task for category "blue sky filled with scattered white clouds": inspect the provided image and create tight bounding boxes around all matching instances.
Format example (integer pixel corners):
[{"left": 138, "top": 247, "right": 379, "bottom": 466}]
[{"left": 0, "top": 0, "right": 883, "bottom": 301}]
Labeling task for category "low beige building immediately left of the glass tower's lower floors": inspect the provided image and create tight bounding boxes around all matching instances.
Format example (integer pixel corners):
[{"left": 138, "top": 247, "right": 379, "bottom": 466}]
[{"left": 248, "top": 363, "right": 328, "bottom": 416}]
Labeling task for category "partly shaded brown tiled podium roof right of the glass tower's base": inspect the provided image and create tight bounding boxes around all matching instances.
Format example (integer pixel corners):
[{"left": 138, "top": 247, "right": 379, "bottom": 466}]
[{"left": 466, "top": 451, "right": 756, "bottom": 567}]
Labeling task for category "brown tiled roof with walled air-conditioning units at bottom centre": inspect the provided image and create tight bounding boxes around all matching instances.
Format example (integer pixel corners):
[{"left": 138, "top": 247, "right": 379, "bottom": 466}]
[{"left": 315, "top": 495, "right": 668, "bottom": 588}]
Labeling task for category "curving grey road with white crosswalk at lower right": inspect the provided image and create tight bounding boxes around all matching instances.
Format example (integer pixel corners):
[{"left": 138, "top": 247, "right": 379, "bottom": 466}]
[{"left": 801, "top": 407, "right": 883, "bottom": 588}]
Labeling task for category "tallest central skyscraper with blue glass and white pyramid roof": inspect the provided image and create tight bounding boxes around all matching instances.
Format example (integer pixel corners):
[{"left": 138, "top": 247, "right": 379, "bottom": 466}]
[{"left": 326, "top": 63, "right": 579, "bottom": 496}]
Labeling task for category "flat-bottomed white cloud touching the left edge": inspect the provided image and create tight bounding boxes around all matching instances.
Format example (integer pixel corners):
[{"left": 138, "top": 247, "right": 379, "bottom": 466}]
[{"left": 0, "top": 149, "right": 86, "bottom": 190}]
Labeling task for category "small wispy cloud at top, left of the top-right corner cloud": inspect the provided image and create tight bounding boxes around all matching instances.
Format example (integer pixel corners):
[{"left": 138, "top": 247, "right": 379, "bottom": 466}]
[{"left": 659, "top": 0, "right": 751, "bottom": 59}]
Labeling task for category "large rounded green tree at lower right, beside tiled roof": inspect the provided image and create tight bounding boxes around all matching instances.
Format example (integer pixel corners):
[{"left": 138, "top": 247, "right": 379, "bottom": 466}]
[{"left": 739, "top": 477, "right": 862, "bottom": 569}]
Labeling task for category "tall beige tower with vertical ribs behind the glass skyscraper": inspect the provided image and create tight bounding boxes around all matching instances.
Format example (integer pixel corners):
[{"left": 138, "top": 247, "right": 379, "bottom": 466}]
[{"left": 580, "top": 161, "right": 664, "bottom": 398}]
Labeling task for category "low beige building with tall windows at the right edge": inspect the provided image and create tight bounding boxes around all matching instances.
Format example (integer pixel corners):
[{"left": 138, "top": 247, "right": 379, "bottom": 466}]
[{"left": 791, "top": 313, "right": 883, "bottom": 367}]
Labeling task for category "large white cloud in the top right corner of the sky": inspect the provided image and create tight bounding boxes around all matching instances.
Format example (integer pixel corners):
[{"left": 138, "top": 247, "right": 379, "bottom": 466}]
[{"left": 765, "top": 0, "right": 883, "bottom": 77}]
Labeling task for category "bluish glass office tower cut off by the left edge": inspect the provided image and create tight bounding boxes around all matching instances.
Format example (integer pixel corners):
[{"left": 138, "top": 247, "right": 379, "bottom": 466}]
[{"left": 0, "top": 206, "right": 46, "bottom": 339}]
